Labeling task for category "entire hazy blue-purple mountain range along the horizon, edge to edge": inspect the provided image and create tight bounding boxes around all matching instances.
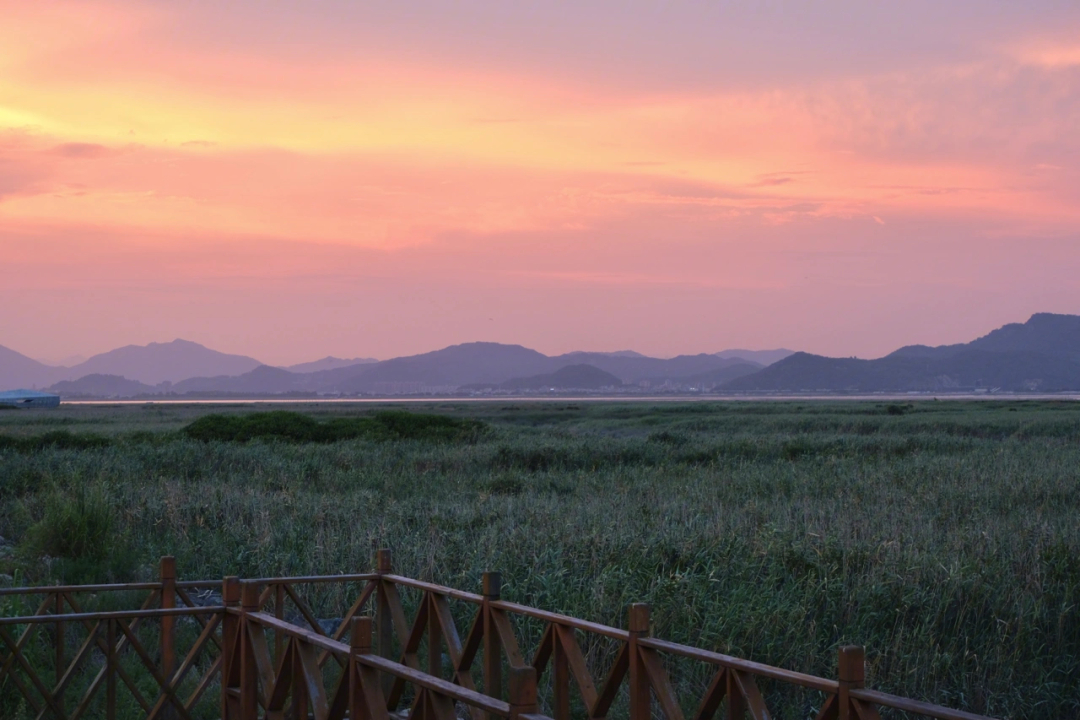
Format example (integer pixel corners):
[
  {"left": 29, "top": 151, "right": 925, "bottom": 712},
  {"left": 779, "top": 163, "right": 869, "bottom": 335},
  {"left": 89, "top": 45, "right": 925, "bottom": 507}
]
[{"left": 6, "top": 313, "right": 1080, "bottom": 397}]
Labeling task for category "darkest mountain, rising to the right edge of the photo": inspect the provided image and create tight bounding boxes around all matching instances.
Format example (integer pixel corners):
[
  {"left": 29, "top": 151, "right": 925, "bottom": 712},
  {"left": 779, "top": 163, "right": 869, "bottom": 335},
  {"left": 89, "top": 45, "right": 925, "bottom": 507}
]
[{"left": 723, "top": 313, "right": 1080, "bottom": 392}]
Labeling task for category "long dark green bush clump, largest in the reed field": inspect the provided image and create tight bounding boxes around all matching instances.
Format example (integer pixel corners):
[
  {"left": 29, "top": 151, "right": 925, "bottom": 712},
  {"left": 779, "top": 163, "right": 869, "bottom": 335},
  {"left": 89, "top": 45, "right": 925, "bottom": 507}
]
[{"left": 184, "top": 410, "right": 484, "bottom": 443}]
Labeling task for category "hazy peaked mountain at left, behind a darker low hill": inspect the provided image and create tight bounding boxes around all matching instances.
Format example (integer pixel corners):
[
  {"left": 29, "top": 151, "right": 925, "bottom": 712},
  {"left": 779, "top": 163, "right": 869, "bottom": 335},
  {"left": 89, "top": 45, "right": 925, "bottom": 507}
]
[{"left": 64, "top": 340, "right": 262, "bottom": 385}]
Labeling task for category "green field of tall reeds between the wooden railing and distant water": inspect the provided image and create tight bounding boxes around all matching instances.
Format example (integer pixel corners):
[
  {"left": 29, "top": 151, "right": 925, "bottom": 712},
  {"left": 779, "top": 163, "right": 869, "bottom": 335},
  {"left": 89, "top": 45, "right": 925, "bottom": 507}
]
[{"left": 0, "top": 400, "right": 1080, "bottom": 718}]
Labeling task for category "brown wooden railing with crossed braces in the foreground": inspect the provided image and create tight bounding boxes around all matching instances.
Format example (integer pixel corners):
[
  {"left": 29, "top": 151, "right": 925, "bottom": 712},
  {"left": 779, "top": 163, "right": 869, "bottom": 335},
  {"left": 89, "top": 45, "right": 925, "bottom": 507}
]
[{"left": 0, "top": 551, "right": 986, "bottom": 720}]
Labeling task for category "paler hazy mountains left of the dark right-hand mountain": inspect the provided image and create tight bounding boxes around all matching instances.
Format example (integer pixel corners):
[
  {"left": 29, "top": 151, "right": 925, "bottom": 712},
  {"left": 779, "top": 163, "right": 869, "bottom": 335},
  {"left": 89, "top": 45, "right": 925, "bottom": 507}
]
[{"left": 0, "top": 340, "right": 792, "bottom": 397}]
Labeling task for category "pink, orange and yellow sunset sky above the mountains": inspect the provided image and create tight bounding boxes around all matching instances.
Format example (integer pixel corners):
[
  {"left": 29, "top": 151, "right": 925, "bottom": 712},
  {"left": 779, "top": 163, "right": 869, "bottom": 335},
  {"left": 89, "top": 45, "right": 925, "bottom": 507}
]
[{"left": 0, "top": 0, "right": 1080, "bottom": 364}]
